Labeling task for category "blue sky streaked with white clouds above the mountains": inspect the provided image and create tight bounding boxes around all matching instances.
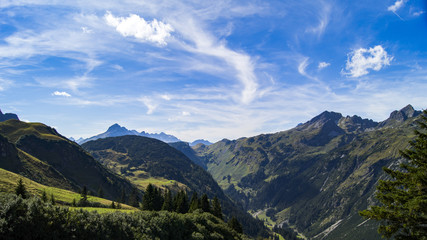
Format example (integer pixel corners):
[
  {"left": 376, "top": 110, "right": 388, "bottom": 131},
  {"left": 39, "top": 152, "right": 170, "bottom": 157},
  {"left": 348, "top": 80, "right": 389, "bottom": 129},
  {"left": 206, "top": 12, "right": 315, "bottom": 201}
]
[{"left": 0, "top": 0, "right": 427, "bottom": 142}]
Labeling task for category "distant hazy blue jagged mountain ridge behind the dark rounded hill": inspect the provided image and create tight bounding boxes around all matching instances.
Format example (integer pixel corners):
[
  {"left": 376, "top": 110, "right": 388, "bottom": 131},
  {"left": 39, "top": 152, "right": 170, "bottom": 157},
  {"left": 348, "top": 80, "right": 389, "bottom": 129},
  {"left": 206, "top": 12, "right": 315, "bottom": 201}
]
[{"left": 76, "top": 123, "right": 180, "bottom": 144}]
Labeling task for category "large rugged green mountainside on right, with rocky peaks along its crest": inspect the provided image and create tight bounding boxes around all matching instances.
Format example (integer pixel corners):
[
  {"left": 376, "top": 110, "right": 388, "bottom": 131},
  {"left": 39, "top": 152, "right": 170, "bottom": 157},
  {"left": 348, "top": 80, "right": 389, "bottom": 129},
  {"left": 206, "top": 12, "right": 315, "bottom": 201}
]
[{"left": 194, "top": 106, "right": 420, "bottom": 239}]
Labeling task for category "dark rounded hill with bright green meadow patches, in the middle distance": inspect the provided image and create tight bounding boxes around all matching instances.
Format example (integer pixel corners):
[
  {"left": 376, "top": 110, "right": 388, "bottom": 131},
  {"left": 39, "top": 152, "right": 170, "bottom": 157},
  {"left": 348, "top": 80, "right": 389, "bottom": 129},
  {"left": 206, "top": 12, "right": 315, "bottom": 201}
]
[{"left": 82, "top": 136, "right": 270, "bottom": 236}]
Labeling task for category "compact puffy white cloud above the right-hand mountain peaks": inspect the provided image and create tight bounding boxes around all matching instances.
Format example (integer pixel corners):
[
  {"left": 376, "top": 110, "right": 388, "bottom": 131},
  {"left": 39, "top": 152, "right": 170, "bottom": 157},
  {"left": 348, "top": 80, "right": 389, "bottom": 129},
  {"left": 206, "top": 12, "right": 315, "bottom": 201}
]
[{"left": 343, "top": 45, "right": 393, "bottom": 77}]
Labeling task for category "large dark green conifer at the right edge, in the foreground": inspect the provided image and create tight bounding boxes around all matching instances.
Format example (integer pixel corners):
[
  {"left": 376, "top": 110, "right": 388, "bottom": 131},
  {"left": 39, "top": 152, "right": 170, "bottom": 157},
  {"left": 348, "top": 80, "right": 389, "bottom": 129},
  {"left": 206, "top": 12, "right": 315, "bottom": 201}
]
[{"left": 360, "top": 110, "right": 427, "bottom": 240}]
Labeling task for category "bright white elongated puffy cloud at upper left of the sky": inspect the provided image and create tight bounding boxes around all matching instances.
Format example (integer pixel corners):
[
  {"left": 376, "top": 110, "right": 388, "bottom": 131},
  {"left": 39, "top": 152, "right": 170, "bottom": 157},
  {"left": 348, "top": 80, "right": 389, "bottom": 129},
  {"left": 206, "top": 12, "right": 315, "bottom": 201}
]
[{"left": 104, "top": 12, "right": 173, "bottom": 45}]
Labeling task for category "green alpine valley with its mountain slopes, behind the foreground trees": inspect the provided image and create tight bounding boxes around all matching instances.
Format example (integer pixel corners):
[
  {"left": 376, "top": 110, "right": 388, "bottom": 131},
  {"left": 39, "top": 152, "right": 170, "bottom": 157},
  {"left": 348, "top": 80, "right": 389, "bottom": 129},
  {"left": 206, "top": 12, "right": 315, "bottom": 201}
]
[{"left": 0, "top": 105, "right": 422, "bottom": 240}]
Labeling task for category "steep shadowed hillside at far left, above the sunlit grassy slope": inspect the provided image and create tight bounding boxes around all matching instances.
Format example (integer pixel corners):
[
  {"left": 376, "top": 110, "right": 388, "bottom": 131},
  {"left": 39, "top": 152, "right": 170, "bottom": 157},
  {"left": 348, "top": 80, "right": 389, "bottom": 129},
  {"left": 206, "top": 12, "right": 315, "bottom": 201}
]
[{"left": 0, "top": 120, "right": 132, "bottom": 200}]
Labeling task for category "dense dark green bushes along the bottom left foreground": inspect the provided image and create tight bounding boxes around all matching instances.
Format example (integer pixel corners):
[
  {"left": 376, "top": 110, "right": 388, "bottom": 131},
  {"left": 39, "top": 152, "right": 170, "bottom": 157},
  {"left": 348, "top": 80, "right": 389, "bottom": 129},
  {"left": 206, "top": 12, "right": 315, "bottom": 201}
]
[{"left": 0, "top": 193, "right": 245, "bottom": 240}]
